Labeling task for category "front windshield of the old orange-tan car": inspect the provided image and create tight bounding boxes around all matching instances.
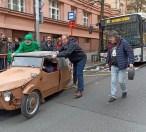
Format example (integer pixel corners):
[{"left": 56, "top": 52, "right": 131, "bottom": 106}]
[{"left": 12, "top": 57, "right": 43, "bottom": 67}]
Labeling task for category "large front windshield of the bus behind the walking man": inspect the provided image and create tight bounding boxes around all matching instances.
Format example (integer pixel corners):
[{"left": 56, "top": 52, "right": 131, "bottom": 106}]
[{"left": 101, "top": 22, "right": 141, "bottom": 50}]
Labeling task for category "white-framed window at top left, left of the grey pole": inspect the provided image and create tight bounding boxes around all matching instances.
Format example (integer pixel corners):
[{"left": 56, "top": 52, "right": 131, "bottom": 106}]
[{"left": 8, "top": 0, "right": 25, "bottom": 12}]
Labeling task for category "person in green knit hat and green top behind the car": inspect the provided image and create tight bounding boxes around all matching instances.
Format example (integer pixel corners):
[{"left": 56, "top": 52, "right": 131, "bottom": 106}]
[{"left": 15, "top": 33, "right": 40, "bottom": 54}]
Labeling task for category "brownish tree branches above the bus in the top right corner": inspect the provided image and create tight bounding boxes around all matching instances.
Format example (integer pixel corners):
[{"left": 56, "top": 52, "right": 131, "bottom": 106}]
[{"left": 127, "top": 0, "right": 146, "bottom": 13}]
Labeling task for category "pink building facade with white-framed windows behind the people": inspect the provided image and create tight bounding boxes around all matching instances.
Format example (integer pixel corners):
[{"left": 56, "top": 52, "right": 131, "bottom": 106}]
[{"left": 0, "top": 0, "right": 121, "bottom": 52}]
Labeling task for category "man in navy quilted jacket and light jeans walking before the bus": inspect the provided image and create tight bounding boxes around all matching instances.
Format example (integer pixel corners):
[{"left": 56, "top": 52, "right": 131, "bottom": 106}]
[{"left": 106, "top": 30, "right": 134, "bottom": 102}]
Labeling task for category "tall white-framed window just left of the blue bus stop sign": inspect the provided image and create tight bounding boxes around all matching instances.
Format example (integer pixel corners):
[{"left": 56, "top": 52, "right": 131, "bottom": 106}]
[{"left": 49, "top": 0, "right": 59, "bottom": 20}]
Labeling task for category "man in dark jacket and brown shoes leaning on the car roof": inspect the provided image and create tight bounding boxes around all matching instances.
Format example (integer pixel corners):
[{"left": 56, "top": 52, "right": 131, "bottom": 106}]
[{"left": 52, "top": 34, "right": 87, "bottom": 97}]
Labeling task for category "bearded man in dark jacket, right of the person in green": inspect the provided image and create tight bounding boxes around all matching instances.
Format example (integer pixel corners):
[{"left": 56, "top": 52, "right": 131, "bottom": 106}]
[{"left": 41, "top": 35, "right": 57, "bottom": 51}]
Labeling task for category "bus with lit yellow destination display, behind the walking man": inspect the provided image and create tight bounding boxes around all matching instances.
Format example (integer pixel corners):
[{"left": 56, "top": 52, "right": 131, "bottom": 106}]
[{"left": 100, "top": 13, "right": 146, "bottom": 62}]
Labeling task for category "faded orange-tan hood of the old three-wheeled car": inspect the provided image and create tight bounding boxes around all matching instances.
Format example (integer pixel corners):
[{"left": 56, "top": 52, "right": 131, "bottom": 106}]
[{"left": 0, "top": 67, "right": 40, "bottom": 91}]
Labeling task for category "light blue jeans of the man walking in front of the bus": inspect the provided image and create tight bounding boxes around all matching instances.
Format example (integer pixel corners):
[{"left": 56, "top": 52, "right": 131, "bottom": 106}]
[{"left": 111, "top": 66, "right": 127, "bottom": 98}]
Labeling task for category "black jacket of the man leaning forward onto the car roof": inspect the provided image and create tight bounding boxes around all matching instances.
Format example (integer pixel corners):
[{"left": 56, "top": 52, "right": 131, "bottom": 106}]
[{"left": 57, "top": 37, "right": 87, "bottom": 63}]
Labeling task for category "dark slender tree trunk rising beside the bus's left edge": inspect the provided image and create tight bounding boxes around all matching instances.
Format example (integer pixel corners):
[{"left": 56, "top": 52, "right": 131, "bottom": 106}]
[{"left": 98, "top": 0, "right": 104, "bottom": 61}]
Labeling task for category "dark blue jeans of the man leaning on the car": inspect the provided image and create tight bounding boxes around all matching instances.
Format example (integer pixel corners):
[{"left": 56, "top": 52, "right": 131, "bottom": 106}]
[{"left": 73, "top": 60, "right": 86, "bottom": 92}]
